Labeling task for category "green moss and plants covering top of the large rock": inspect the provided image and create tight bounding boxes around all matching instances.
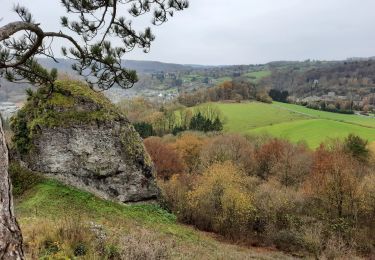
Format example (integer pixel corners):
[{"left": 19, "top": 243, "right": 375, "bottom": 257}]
[{"left": 11, "top": 81, "right": 126, "bottom": 154}]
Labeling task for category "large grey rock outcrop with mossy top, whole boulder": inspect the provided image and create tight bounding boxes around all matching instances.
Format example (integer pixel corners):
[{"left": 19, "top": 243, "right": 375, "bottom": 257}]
[{"left": 13, "top": 82, "right": 158, "bottom": 202}]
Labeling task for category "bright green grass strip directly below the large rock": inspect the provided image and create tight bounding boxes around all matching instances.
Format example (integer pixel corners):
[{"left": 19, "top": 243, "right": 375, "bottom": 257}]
[{"left": 16, "top": 179, "right": 184, "bottom": 233}]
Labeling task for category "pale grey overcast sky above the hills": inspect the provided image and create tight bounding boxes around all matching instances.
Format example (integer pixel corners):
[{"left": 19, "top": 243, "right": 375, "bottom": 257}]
[{"left": 0, "top": 0, "right": 375, "bottom": 65}]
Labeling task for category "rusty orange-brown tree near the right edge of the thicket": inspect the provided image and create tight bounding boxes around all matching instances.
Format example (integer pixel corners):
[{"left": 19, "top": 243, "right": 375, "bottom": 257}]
[{"left": 305, "top": 146, "right": 361, "bottom": 218}]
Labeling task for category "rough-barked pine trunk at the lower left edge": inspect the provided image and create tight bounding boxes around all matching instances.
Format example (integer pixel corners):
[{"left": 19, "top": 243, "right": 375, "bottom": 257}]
[{"left": 0, "top": 118, "right": 24, "bottom": 260}]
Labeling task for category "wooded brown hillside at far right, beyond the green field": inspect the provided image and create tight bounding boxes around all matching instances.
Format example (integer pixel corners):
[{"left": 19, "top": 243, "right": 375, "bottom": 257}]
[{"left": 262, "top": 58, "right": 375, "bottom": 97}]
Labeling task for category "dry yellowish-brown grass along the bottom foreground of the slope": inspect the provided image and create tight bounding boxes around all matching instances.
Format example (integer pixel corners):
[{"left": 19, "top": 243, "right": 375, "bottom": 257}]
[{"left": 20, "top": 214, "right": 292, "bottom": 260}]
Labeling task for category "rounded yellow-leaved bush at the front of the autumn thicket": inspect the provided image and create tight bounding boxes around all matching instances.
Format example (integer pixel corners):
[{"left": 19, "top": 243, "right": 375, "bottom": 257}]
[{"left": 188, "top": 162, "right": 255, "bottom": 238}]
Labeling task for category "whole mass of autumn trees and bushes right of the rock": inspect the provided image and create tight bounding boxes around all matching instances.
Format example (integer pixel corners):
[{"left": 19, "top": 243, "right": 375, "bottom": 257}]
[{"left": 153, "top": 132, "right": 375, "bottom": 258}]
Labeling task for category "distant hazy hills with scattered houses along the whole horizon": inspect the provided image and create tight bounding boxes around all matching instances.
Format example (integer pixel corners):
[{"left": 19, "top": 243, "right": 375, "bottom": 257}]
[{"left": 0, "top": 57, "right": 375, "bottom": 102}]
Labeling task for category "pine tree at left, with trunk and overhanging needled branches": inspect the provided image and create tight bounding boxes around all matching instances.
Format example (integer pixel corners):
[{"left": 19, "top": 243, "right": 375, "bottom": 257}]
[{"left": 0, "top": 0, "right": 189, "bottom": 259}]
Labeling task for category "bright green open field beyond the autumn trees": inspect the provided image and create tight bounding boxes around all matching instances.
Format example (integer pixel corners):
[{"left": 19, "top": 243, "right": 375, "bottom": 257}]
[{"left": 218, "top": 102, "right": 375, "bottom": 148}]
